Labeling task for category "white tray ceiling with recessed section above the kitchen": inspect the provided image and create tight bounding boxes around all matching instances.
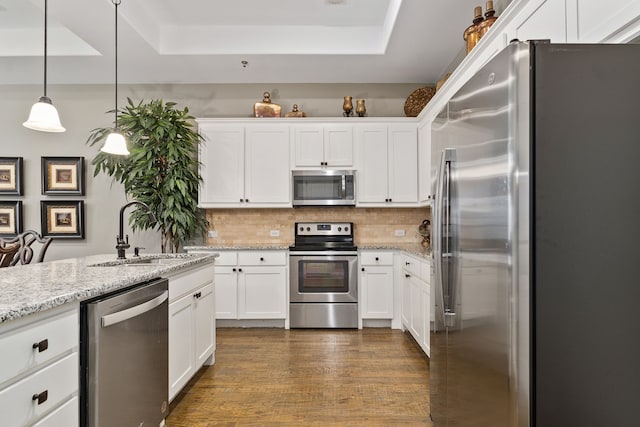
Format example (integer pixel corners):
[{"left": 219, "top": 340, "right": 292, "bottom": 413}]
[{"left": 0, "top": 0, "right": 482, "bottom": 84}]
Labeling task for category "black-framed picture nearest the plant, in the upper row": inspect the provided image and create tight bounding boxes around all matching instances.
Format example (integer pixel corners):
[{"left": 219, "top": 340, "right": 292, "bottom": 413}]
[{"left": 41, "top": 157, "right": 84, "bottom": 196}]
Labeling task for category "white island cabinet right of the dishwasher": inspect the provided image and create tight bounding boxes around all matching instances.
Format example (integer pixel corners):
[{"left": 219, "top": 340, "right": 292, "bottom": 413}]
[{"left": 169, "top": 264, "right": 216, "bottom": 400}]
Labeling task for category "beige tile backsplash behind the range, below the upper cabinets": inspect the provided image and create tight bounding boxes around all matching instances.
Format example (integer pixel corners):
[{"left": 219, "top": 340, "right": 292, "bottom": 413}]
[{"left": 205, "top": 207, "right": 431, "bottom": 246}]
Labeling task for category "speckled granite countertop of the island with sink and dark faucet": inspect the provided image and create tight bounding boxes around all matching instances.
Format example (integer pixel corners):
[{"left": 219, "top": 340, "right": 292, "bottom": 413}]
[{"left": 0, "top": 253, "right": 218, "bottom": 324}]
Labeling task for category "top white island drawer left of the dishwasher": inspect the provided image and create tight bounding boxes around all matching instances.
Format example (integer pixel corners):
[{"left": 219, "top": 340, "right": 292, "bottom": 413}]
[{"left": 0, "top": 309, "right": 80, "bottom": 384}]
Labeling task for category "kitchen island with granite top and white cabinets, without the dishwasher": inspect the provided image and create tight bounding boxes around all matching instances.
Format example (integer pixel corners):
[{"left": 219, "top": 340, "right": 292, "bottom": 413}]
[{"left": 0, "top": 253, "right": 218, "bottom": 426}]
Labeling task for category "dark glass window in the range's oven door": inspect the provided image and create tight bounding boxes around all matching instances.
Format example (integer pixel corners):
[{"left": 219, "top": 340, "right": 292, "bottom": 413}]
[{"left": 298, "top": 260, "right": 349, "bottom": 293}]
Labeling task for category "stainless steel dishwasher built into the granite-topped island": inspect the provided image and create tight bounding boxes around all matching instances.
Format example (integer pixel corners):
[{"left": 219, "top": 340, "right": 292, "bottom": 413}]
[{"left": 80, "top": 279, "right": 169, "bottom": 427}]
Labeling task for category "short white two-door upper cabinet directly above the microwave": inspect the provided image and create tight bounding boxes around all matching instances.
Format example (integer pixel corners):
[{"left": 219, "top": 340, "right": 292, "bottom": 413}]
[{"left": 293, "top": 124, "right": 353, "bottom": 168}]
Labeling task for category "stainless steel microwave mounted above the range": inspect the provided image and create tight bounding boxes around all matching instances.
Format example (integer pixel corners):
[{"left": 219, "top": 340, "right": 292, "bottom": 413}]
[{"left": 292, "top": 169, "right": 356, "bottom": 206}]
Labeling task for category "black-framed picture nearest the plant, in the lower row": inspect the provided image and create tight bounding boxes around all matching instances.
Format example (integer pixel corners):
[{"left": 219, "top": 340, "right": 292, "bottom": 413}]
[{"left": 40, "top": 200, "right": 84, "bottom": 239}]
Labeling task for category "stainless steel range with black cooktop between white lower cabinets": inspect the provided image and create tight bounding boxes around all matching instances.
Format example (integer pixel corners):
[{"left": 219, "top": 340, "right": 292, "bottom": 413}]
[{"left": 289, "top": 222, "right": 358, "bottom": 328}]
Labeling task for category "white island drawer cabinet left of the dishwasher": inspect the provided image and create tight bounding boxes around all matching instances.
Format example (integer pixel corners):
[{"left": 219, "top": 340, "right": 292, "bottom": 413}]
[{"left": 0, "top": 304, "right": 80, "bottom": 427}]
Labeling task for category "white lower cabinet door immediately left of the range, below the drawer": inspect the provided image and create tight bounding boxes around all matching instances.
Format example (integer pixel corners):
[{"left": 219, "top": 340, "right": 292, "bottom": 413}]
[{"left": 238, "top": 266, "right": 287, "bottom": 319}]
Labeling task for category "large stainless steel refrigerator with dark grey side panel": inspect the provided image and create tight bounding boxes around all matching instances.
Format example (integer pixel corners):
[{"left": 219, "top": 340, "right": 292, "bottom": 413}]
[{"left": 430, "top": 42, "right": 640, "bottom": 427}]
